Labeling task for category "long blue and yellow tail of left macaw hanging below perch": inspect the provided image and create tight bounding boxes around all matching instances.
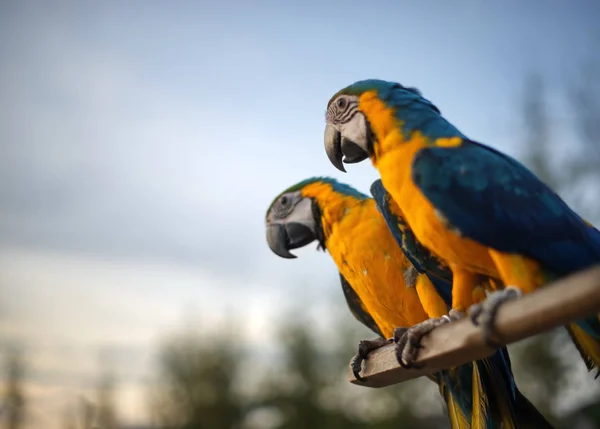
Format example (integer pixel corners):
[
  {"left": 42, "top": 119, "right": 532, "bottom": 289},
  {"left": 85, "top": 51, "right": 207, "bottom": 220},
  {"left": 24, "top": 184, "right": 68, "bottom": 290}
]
[{"left": 438, "top": 348, "right": 552, "bottom": 429}]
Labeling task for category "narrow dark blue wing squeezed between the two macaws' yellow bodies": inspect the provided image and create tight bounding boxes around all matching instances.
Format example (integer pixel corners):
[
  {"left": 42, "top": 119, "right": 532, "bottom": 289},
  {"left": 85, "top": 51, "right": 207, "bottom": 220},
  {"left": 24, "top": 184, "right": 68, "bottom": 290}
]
[{"left": 371, "top": 180, "right": 452, "bottom": 305}]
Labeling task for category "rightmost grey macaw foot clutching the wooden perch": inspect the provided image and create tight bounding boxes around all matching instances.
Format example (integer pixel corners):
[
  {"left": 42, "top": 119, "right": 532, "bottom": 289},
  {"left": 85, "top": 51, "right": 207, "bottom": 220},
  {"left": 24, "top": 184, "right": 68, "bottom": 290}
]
[{"left": 469, "top": 286, "right": 523, "bottom": 348}]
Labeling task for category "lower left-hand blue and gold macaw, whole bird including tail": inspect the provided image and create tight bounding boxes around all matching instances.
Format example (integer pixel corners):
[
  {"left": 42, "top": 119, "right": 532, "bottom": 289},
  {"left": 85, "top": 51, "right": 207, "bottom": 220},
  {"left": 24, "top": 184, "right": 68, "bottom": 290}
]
[{"left": 266, "top": 177, "right": 551, "bottom": 428}]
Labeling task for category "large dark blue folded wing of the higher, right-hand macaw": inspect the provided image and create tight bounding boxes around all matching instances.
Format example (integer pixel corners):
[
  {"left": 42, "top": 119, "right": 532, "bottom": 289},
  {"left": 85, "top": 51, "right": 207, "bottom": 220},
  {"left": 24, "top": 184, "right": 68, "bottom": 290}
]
[{"left": 411, "top": 140, "right": 600, "bottom": 275}]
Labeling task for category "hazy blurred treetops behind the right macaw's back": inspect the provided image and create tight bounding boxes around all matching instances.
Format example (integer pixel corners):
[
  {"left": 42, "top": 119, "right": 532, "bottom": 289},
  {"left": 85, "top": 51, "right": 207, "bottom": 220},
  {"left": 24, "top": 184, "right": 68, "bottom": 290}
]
[{"left": 520, "top": 62, "right": 600, "bottom": 223}]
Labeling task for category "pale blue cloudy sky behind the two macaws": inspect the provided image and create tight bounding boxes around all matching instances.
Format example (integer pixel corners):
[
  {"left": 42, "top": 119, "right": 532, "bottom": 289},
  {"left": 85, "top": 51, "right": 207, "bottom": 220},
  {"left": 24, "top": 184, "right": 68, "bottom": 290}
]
[{"left": 0, "top": 0, "right": 600, "bottom": 419}]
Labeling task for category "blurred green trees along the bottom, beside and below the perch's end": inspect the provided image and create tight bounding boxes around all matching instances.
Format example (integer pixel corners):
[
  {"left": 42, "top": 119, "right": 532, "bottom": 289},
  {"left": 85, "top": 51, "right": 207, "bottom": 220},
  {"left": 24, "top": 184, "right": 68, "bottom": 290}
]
[{"left": 151, "top": 304, "right": 447, "bottom": 429}]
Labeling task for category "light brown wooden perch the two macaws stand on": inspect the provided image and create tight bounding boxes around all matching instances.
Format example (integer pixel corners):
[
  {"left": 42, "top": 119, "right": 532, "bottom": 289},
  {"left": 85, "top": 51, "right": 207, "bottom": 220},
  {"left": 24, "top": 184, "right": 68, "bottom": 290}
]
[{"left": 349, "top": 266, "right": 600, "bottom": 387}]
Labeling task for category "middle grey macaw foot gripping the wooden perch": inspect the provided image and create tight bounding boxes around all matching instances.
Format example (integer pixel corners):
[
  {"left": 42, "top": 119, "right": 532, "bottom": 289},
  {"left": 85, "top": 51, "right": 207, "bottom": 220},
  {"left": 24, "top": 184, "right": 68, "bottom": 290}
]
[{"left": 394, "top": 313, "right": 459, "bottom": 369}]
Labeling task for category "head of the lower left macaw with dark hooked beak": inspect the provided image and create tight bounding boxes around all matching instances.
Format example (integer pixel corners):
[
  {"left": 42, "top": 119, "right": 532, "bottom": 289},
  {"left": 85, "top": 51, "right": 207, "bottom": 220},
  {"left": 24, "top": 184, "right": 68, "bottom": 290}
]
[{"left": 266, "top": 177, "right": 368, "bottom": 259}]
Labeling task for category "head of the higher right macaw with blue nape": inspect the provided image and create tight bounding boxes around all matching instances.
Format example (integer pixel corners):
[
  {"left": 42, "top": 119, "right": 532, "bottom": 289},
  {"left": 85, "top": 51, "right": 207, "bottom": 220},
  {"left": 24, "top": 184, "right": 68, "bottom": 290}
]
[{"left": 325, "top": 79, "right": 452, "bottom": 172}]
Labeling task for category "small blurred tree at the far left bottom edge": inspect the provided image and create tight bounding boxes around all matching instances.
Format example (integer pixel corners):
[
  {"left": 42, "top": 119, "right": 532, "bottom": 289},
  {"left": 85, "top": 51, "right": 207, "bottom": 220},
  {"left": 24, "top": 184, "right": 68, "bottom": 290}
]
[{"left": 0, "top": 346, "right": 27, "bottom": 429}]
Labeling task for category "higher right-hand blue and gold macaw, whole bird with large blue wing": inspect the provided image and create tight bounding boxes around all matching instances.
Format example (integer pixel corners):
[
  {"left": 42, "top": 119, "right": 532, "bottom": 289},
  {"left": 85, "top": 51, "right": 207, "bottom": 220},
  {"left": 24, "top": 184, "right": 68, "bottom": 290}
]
[{"left": 325, "top": 79, "right": 600, "bottom": 370}]
